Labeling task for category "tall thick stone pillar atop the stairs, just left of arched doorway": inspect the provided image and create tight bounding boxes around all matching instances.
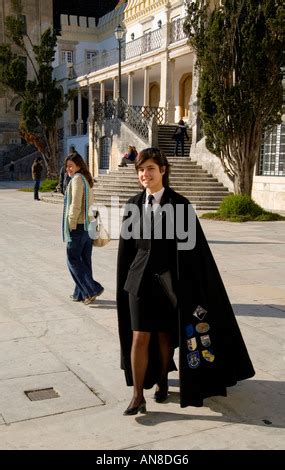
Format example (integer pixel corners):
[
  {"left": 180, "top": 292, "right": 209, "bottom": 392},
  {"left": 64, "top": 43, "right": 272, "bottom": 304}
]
[{"left": 159, "top": 52, "right": 175, "bottom": 123}]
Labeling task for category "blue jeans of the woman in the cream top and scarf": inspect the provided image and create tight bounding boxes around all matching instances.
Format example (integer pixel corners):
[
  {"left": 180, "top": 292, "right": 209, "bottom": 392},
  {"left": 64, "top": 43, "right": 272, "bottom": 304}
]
[{"left": 67, "top": 224, "right": 103, "bottom": 300}]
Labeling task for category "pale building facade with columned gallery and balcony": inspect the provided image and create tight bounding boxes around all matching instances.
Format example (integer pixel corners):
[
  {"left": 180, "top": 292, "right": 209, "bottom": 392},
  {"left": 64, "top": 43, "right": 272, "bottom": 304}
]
[{"left": 55, "top": 0, "right": 285, "bottom": 210}]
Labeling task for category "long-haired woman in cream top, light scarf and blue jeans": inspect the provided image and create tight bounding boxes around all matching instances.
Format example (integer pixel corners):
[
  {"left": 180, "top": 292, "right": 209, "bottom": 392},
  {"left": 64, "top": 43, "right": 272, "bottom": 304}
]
[{"left": 63, "top": 153, "right": 104, "bottom": 305}]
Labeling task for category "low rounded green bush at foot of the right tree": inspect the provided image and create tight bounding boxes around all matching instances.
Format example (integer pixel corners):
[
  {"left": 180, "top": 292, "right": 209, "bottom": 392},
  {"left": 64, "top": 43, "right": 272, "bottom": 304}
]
[{"left": 201, "top": 194, "right": 285, "bottom": 222}]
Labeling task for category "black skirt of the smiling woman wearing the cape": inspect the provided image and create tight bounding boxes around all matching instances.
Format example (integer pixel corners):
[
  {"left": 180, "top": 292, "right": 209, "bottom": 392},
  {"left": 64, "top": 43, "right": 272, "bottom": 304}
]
[{"left": 129, "top": 276, "right": 177, "bottom": 332}]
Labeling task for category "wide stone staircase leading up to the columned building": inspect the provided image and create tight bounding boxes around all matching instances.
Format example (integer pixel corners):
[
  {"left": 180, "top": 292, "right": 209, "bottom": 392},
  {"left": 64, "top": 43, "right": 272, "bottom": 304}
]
[{"left": 41, "top": 125, "right": 229, "bottom": 211}]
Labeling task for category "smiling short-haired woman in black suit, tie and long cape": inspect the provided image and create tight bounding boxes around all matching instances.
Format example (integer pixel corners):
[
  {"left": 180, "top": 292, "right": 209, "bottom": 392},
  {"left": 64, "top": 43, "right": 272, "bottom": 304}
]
[{"left": 117, "top": 148, "right": 255, "bottom": 415}]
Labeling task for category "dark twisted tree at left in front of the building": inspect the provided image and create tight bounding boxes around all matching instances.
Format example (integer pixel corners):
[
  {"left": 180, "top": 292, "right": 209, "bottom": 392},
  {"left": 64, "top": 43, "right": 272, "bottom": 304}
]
[{"left": 0, "top": 0, "right": 75, "bottom": 177}]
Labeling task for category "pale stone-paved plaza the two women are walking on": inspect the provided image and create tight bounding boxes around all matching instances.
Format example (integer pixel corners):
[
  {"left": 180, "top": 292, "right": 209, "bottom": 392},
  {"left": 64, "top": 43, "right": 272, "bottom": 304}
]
[{"left": 0, "top": 183, "right": 285, "bottom": 450}]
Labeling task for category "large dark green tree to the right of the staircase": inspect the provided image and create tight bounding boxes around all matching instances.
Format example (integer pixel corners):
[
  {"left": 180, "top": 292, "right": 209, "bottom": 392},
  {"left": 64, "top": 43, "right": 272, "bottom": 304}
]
[{"left": 184, "top": 0, "right": 285, "bottom": 195}]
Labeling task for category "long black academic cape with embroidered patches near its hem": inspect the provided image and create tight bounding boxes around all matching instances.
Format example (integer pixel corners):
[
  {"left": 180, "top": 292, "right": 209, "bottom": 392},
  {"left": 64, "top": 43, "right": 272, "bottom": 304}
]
[{"left": 117, "top": 188, "right": 255, "bottom": 407}]
